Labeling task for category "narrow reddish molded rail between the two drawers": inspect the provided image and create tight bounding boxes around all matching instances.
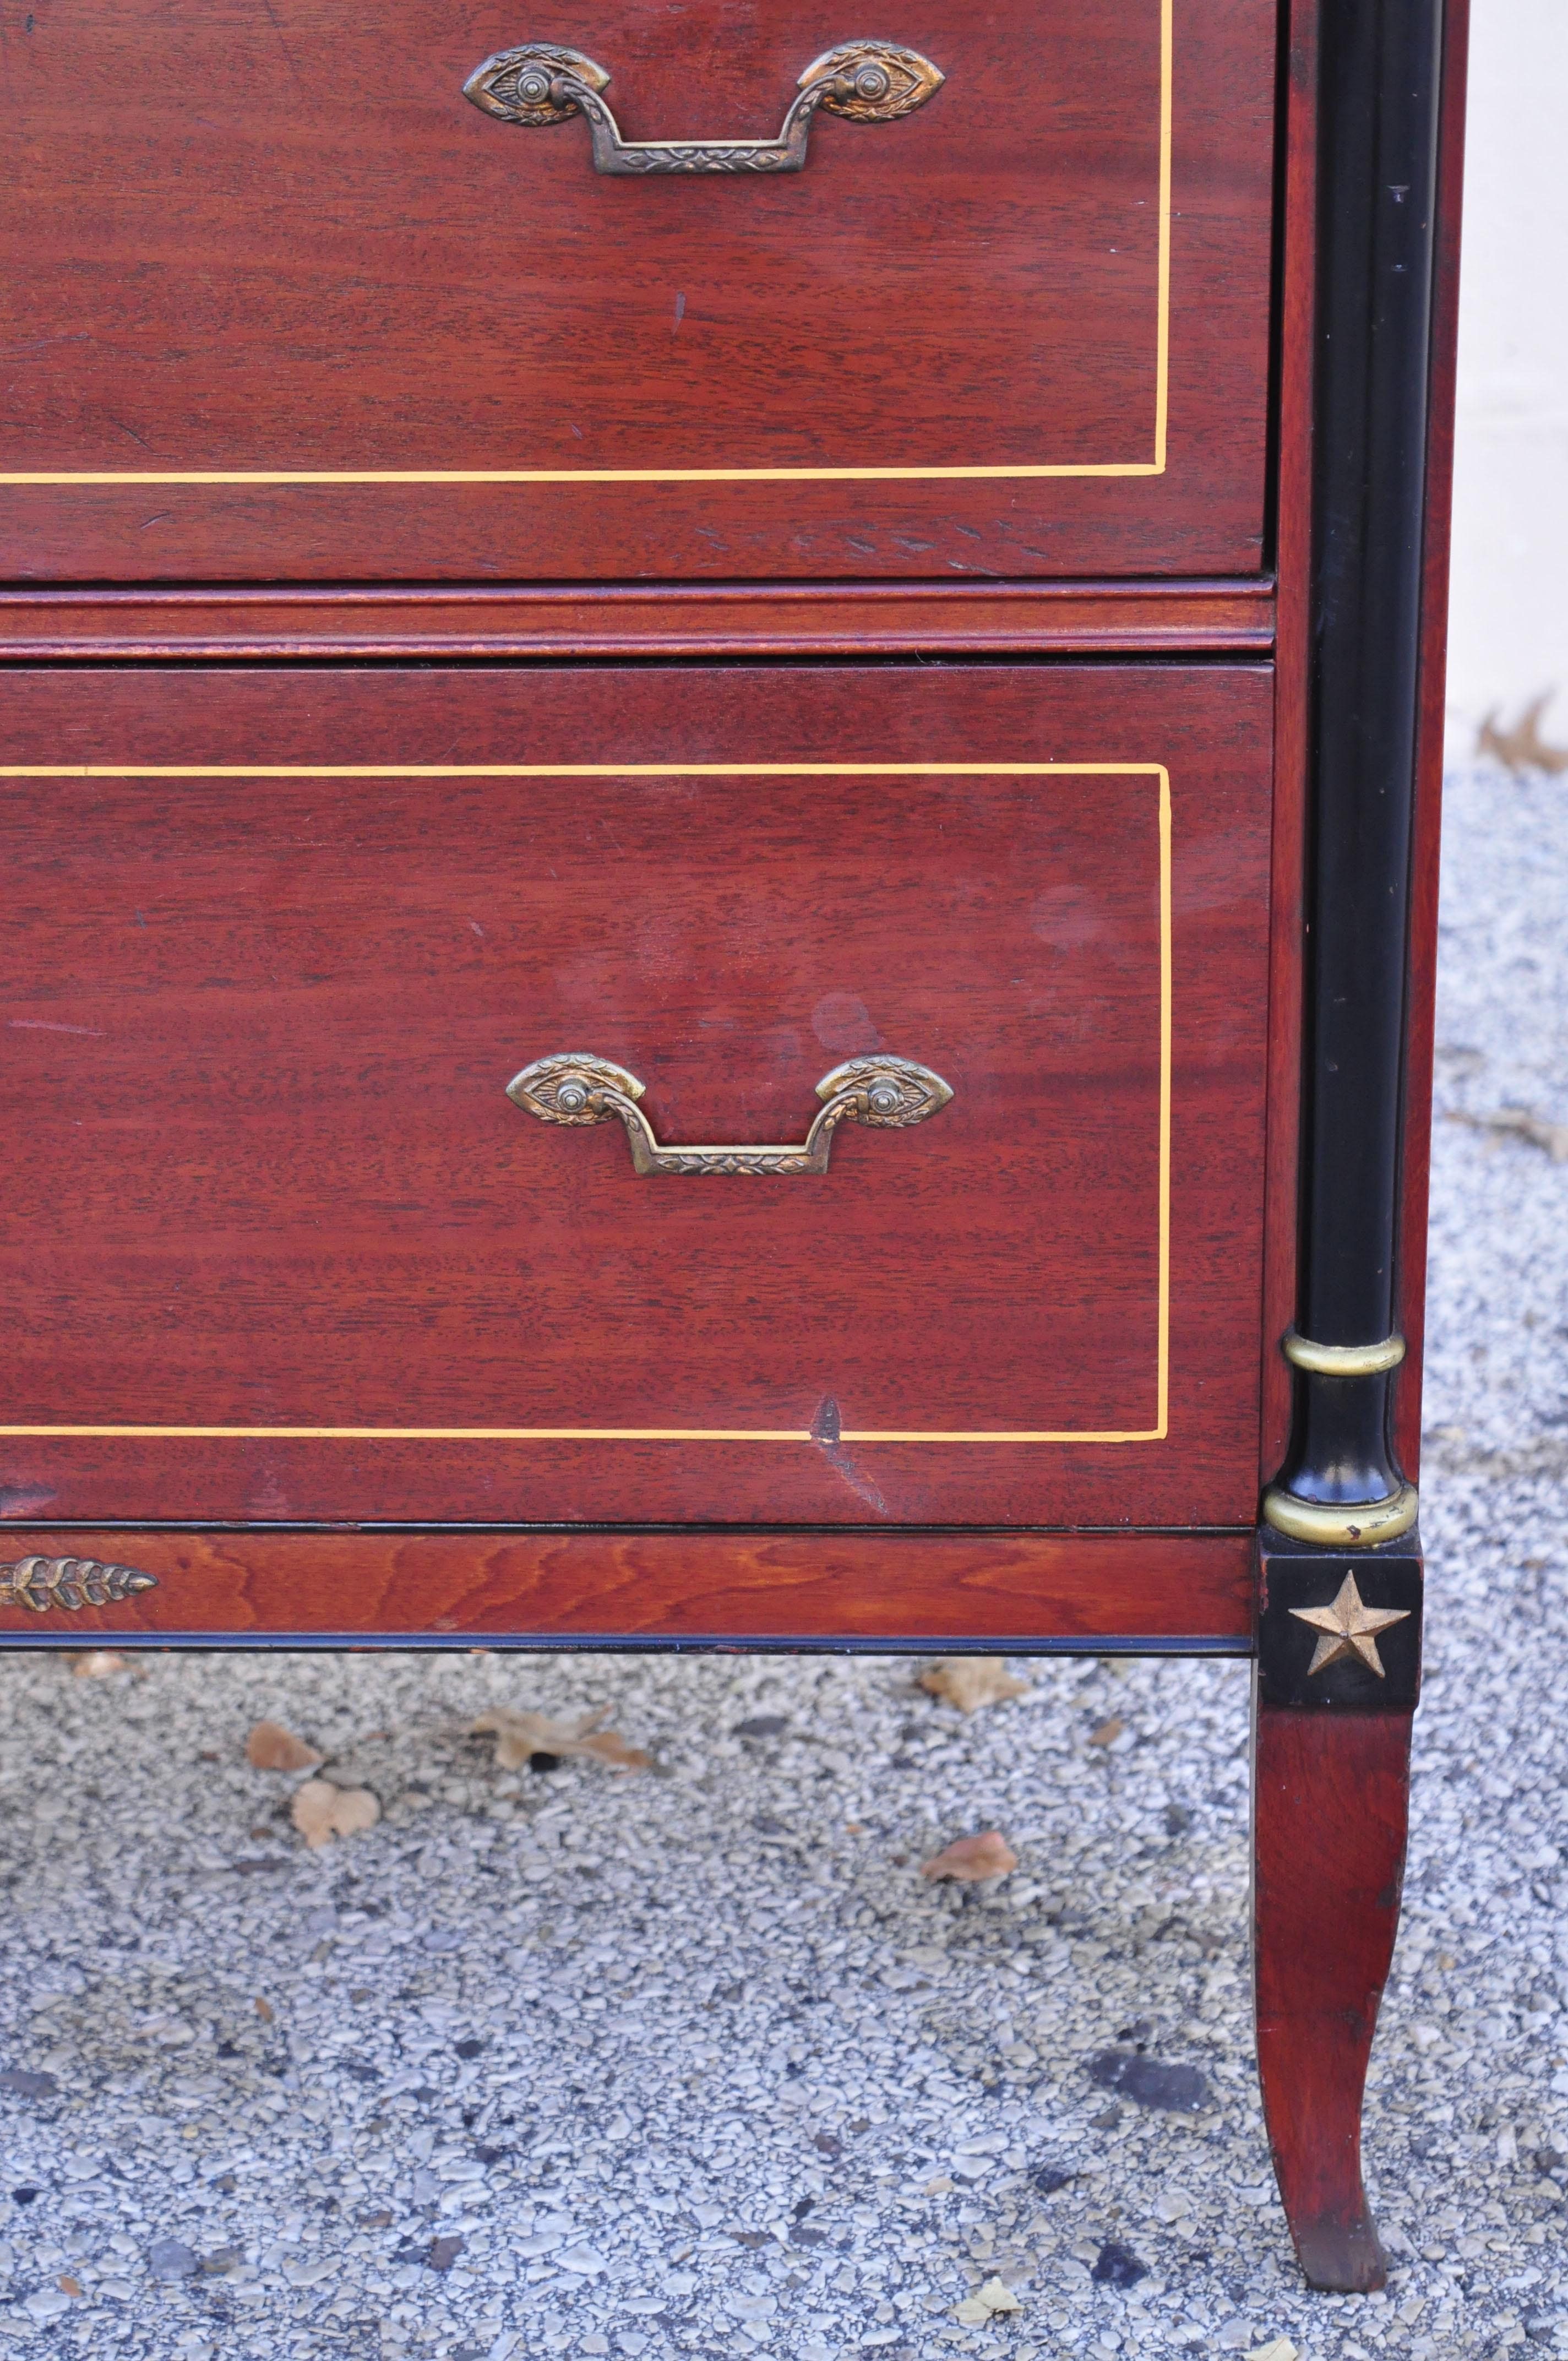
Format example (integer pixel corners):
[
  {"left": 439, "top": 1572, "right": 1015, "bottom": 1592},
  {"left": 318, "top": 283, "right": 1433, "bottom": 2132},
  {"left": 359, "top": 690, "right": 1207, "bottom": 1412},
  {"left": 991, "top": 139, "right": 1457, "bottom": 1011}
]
[{"left": 0, "top": 574, "right": 1275, "bottom": 663}]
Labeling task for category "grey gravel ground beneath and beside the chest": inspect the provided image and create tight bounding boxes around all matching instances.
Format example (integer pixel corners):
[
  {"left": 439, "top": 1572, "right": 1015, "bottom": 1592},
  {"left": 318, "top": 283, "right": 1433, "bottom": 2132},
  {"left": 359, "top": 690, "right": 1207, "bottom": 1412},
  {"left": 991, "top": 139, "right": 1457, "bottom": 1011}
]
[{"left": 0, "top": 772, "right": 1568, "bottom": 2361}]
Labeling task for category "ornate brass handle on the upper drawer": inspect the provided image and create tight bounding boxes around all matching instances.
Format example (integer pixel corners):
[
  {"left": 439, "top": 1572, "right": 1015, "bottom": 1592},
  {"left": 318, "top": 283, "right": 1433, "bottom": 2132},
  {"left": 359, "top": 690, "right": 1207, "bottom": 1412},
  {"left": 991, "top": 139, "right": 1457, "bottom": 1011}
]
[{"left": 463, "top": 40, "right": 942, "bottom": 179}]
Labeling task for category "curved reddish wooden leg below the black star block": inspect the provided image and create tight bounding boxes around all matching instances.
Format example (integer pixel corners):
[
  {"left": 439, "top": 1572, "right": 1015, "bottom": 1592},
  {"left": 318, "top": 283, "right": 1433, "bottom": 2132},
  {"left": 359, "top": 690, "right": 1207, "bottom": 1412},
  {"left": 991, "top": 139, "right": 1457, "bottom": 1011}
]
[{"left": 1251, "top": 1707, "right": 1410, "bottom": 2293}]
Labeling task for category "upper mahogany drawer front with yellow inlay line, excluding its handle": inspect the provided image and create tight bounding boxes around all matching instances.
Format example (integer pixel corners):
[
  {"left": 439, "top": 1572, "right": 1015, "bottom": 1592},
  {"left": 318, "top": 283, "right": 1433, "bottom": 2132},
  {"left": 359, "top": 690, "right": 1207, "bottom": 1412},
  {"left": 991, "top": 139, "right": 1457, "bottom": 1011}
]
[{"left": 0, "top": 0, "right": 1275, "bottom": 581}]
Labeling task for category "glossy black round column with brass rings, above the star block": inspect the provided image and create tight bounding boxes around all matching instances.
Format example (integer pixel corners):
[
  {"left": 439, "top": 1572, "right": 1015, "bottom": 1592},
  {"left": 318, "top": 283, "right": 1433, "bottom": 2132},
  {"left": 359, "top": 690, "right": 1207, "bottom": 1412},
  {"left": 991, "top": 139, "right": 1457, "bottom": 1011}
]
[{"left": 1266, "top": 0, "right": 1443, "bottom": 1544}]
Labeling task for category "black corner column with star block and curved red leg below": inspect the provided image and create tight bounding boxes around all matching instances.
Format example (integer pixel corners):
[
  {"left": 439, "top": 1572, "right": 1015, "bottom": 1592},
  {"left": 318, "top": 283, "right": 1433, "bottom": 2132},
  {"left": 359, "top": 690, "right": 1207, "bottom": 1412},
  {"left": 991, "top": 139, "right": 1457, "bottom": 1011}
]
[{"left": 1254, "top": 0, "right": 1443, "bottom": 2290}]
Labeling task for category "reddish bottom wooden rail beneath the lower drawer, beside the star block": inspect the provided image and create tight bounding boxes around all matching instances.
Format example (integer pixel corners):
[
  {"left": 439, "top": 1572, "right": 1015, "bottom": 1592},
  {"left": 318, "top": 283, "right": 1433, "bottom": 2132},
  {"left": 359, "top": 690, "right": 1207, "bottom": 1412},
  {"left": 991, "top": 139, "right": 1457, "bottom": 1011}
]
[{"left": 0, "top": 1525, "right": 1251, "bottom": 1653}]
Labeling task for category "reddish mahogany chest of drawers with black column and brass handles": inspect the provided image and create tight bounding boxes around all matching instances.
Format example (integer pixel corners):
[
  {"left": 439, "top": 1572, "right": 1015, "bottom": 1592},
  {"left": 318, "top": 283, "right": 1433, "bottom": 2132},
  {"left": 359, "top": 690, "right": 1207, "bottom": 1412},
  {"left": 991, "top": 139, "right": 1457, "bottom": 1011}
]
[{"left": 0, "top": 0, "right": 1464, "bottom": 2288}]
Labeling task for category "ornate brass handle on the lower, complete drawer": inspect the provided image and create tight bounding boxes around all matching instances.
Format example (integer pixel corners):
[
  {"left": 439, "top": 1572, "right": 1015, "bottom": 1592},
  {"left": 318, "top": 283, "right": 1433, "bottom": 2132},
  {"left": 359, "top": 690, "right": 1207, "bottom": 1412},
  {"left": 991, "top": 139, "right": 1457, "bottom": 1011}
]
[{"left": 505, "top": 1051, "right": 952, "bottom": 1173}]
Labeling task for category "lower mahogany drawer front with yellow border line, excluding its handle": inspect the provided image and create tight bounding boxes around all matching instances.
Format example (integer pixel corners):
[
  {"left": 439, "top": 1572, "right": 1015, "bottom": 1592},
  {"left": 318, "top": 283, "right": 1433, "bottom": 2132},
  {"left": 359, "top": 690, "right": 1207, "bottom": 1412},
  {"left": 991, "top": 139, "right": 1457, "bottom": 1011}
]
[{"left": 0, "top": 666, "right": 1273, "bottom": 1525}]
